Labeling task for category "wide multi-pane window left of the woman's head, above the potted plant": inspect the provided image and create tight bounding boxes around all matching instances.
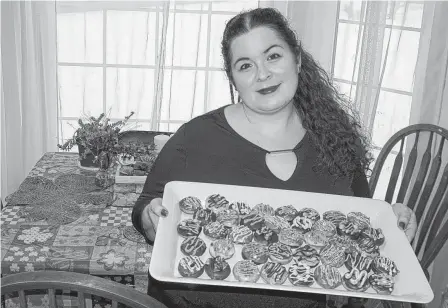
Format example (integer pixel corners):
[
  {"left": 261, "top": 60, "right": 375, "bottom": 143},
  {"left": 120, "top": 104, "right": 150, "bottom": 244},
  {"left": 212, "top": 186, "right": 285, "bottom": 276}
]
[{"left": 57, "top": 0, "right": 258, "bottom": 147}]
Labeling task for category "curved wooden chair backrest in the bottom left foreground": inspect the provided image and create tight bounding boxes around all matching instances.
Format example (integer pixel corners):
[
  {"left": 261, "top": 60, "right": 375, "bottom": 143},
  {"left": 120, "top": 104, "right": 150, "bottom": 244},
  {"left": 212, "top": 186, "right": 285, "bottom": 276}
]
[{"left": 1, "top": 271, "right": 167, "bottom": 308}]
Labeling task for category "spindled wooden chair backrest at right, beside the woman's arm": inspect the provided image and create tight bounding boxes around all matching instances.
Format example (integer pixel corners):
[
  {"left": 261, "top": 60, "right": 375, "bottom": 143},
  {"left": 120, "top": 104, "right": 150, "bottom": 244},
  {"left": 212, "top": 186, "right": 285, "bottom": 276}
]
[{"left": 369, "top": 124, "right": 448, "bottom": 269}]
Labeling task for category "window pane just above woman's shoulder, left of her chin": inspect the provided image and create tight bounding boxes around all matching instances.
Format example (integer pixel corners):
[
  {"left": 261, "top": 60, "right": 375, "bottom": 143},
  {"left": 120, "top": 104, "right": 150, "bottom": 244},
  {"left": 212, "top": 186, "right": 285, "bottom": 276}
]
[{"left": 161, "top": 69, "right": 205, "bottom": 121}]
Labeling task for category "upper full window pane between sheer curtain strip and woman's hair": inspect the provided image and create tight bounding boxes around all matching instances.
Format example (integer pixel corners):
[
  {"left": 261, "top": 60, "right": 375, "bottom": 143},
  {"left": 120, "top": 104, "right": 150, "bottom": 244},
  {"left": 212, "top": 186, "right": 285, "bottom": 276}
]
[{"left": 165, "top": 13, "right": 208, "bottom": 67}]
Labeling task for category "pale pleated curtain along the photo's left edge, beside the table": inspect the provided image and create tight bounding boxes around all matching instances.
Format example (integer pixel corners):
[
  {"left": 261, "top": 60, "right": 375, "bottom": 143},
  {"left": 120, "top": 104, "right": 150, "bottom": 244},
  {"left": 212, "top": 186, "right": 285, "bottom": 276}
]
[{"left": 1, "top": 1, "right": 57, "bottom": 198}]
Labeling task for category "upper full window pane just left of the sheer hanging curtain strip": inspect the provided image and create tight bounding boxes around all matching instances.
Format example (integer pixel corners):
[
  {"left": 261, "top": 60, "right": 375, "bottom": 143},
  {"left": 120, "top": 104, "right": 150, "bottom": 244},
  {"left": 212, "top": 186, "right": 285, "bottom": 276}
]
[{"left": 106, "top": 11, "right": 157, "bottom": 65}]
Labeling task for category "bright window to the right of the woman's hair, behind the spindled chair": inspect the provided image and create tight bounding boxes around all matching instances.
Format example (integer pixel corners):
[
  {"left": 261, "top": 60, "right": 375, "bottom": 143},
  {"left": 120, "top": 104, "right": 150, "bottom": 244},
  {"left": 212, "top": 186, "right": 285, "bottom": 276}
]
[{"left": 332, "top": 1, "right": 424, "bottom": 196}]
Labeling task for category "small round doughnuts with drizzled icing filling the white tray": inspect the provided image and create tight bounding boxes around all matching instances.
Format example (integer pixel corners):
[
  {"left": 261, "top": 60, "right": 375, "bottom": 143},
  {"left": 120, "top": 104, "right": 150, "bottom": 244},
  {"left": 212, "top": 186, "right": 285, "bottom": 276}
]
[{"left": 177, "top": 194, "right": 398, "bottom": 294}]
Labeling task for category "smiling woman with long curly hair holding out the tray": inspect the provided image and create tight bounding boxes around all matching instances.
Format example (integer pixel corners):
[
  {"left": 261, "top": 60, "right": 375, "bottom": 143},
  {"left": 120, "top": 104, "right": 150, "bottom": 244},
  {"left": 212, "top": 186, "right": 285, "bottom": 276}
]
[{"left": 132, "top": 8, "right": 414, "bottom": 308}]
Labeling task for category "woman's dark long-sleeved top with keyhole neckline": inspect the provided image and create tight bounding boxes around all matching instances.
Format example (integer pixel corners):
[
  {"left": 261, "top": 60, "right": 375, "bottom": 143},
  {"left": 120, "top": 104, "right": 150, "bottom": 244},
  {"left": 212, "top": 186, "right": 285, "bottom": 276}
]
[{"left": 132, "top": 107, "right": 370, "bottom": 233}]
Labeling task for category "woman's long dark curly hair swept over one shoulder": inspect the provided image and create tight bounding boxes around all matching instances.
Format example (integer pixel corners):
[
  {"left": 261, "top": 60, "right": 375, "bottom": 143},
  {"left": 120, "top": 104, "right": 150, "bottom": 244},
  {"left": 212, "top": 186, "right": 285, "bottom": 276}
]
[{"left": 221, "top": 8, "right": 373, "bottom": 177}]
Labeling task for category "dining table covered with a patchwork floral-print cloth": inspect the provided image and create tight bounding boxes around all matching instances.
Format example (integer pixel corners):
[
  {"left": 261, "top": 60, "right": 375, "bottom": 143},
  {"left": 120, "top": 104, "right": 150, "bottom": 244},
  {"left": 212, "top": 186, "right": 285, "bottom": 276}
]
[{"left": 1, "top": 152, "right": 152, "bottom": 308}]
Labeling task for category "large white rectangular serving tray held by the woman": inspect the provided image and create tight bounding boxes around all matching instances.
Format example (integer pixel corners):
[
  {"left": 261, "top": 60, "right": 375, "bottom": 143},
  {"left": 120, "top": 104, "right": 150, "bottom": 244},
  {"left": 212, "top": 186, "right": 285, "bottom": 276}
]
[{"left": 149, "top": 181, "right": 434, "bottom": 303}]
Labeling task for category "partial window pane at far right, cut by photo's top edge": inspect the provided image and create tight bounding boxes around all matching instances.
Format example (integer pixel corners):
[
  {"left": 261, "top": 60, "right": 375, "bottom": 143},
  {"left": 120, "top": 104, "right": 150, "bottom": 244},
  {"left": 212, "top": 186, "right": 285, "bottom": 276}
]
[{"left": 386, "top": 1, "right": 424, "bottom": 28}]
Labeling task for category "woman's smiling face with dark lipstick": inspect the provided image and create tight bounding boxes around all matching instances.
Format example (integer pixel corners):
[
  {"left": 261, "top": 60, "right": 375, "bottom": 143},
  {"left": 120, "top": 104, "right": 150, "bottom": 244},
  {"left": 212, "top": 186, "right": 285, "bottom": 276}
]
[{"left": 230, "top": 27, "right": 299, "bottom": 114}]
